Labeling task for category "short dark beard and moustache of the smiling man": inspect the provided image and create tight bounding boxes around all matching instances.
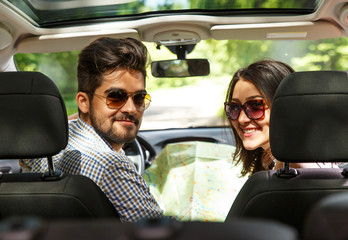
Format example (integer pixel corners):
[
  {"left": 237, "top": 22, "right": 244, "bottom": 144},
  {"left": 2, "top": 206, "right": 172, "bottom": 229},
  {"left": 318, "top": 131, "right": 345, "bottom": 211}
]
[{"left": 89, "top": 107, "right": 139, "bottom": 144}]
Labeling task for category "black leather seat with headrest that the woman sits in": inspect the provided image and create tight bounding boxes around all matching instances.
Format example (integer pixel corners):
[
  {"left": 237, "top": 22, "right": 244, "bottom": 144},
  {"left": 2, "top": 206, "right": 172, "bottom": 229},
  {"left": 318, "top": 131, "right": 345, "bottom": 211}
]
[{"left": 226, "top": 71, "right": 348, "bottom": 234}]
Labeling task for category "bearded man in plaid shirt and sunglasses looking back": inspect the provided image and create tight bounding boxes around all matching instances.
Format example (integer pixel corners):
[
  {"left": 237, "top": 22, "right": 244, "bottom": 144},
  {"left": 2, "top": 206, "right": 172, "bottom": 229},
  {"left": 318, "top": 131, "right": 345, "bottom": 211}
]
[{"left": 21, "top": 38, "right": 162, "bottom": 222}]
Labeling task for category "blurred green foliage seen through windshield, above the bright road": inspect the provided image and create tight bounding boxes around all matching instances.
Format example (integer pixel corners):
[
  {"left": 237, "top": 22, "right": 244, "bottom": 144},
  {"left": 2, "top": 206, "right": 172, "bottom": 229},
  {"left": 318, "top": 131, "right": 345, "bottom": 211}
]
[{"left": 15, "top": 37, "right": 348, "bottom": 115}]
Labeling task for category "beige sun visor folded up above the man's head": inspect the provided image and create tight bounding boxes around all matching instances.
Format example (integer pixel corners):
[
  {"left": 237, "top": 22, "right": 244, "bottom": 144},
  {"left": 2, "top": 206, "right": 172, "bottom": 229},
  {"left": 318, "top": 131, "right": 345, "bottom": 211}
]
[{"left": 17, "top": 29, "right": 140, "bottom": 53}]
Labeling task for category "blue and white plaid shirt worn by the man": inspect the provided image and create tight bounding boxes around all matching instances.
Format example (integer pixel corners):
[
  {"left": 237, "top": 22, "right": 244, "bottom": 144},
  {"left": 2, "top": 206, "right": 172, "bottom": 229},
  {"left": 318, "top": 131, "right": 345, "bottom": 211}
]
[{"left": 20, "top": 118, "right": 163, "bottom": 222}]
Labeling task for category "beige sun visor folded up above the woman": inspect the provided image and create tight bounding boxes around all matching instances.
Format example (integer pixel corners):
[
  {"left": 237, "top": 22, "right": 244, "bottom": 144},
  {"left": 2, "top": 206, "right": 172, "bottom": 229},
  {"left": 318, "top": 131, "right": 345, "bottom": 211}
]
[{"left": 210, "top": 21, "right": 342, "bottom": 40}]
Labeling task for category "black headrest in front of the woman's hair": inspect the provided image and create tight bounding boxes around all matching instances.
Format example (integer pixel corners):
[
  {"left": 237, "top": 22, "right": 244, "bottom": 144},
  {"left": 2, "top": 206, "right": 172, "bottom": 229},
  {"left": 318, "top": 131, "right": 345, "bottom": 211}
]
[{"left": 270, "top": 71, "right": 348, "bottom": 162}]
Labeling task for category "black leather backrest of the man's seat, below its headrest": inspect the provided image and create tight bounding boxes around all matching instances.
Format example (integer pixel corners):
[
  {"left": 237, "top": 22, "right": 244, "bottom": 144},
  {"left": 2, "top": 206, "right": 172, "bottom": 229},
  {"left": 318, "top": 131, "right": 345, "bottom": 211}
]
[{"left": 0, "top": 173, "right": 117, "bottom": 220}]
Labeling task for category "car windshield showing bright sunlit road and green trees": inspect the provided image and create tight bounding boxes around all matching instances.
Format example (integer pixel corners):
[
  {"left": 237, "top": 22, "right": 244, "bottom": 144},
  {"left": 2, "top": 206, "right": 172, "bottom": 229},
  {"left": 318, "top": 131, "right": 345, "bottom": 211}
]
[{"left": 15, "top": 37, "right": 348, "bottom": 130}]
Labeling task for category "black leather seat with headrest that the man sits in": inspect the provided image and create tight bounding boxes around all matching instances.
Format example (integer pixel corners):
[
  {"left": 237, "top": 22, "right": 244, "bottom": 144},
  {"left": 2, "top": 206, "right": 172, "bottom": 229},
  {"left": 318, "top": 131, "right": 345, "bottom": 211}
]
[{"left": 0, "top": 72, "right": 118, "bottom": 219}]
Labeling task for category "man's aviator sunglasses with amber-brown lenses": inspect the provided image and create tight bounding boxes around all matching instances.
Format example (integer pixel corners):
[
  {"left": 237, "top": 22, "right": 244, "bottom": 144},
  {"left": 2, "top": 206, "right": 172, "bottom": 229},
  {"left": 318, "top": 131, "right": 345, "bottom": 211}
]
[{"left": 93, "top": 89, "right": 151, "bottom": 111}]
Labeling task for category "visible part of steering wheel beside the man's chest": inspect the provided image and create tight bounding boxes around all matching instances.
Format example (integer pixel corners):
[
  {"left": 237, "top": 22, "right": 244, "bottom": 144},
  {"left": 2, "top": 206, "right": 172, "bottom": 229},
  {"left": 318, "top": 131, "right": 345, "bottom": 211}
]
[{"left": 123, "top": 139, "right": 146, "bottom": 176}]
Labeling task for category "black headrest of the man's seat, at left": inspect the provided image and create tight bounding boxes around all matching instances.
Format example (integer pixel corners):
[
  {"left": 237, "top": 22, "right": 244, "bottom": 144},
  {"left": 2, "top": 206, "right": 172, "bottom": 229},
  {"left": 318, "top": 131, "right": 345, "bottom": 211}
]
[{"left": 0, "top": 72, "right": 68, "bottom": 159}]
